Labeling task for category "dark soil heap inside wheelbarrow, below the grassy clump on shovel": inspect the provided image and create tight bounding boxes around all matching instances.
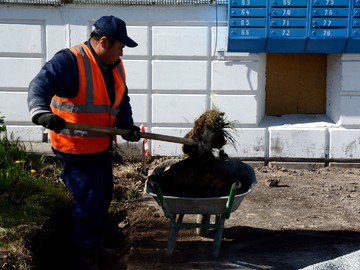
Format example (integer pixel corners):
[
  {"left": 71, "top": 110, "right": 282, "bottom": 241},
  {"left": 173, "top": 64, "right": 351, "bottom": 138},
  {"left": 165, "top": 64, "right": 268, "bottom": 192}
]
[{"left": 148, "top": 158, "right": 251, "bottom": 198}]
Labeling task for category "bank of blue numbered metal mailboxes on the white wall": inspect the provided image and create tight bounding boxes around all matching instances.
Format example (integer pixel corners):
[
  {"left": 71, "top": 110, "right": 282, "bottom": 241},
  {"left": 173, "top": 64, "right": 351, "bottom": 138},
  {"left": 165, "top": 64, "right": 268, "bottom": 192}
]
[{"left": 228, "top": 0, "right": 360, "bottom": 53}]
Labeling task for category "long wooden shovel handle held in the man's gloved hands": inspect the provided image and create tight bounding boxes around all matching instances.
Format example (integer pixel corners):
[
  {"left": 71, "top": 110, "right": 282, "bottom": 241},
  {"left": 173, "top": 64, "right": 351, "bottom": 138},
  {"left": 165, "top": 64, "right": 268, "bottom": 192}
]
[{"left": 65, "top": 122, "right": 195, "bottom": 145}]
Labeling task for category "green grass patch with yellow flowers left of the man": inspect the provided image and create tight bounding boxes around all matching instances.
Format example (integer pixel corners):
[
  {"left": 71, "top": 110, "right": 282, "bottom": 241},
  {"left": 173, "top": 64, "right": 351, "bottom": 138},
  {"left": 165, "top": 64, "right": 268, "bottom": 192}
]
[{"left": 0, "top": 138, "right": 70, "bottom": 227}]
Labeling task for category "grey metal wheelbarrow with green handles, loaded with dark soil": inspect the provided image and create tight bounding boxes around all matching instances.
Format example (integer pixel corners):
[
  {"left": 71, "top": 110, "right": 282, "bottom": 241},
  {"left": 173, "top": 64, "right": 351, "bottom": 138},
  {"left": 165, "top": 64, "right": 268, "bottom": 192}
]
[{"left": 146, "top": 160, "right": 256, "bottom": 258}]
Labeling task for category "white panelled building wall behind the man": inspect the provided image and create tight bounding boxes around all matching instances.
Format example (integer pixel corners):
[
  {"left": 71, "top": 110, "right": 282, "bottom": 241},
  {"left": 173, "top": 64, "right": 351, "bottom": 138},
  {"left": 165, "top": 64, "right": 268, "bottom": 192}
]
[{"left": 0, "top": 5, "right": 360, "bottom": 160}]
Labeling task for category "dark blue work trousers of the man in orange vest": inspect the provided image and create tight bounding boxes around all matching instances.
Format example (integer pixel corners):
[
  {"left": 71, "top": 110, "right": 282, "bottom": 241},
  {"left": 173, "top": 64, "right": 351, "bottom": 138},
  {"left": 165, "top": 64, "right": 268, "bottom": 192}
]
[{"left": 61, "top": 152, "right": 113, "bottom": 248}]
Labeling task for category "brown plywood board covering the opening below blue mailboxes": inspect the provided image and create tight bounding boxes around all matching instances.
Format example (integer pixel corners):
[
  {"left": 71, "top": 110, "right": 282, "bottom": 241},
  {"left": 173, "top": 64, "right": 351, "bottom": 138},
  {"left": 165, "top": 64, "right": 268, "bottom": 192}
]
[{"left": 265, "top": 54, "right": 327, "bottom": 115}]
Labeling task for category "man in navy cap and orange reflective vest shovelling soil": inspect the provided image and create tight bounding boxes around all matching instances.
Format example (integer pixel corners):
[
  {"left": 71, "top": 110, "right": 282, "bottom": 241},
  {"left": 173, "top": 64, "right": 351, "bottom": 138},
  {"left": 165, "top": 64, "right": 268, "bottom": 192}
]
[{"left": 28, "top": 16, "right": 140, "bottom": 270}]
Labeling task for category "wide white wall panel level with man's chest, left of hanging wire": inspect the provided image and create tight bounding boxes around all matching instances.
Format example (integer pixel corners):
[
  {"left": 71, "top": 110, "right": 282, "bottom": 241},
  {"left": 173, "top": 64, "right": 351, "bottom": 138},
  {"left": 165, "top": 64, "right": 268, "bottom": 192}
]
[{"left": 153, "top": 61, "right": 207, "bottom": 90}]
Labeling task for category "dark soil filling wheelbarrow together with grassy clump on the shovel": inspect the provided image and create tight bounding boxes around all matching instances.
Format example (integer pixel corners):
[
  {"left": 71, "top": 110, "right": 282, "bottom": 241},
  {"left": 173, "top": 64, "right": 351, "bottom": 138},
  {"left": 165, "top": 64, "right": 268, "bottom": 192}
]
[{"left": 145, "top": 108, "right": 251, "bottom": 198}]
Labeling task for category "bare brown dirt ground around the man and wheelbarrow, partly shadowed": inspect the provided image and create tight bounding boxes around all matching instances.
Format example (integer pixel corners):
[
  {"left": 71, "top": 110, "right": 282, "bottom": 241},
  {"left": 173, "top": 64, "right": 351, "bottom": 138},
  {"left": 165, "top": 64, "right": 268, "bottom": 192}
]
[{"left": 0, "top": 158, "right": 360, "bottom": 270}]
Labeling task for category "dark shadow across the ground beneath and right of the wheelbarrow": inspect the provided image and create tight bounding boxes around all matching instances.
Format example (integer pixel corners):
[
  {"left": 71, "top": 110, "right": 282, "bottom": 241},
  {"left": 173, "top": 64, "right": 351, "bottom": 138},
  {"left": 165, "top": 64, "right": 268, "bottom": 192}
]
[{"left": 128, "top": 226, "right": 360, "bottom": 270}]
